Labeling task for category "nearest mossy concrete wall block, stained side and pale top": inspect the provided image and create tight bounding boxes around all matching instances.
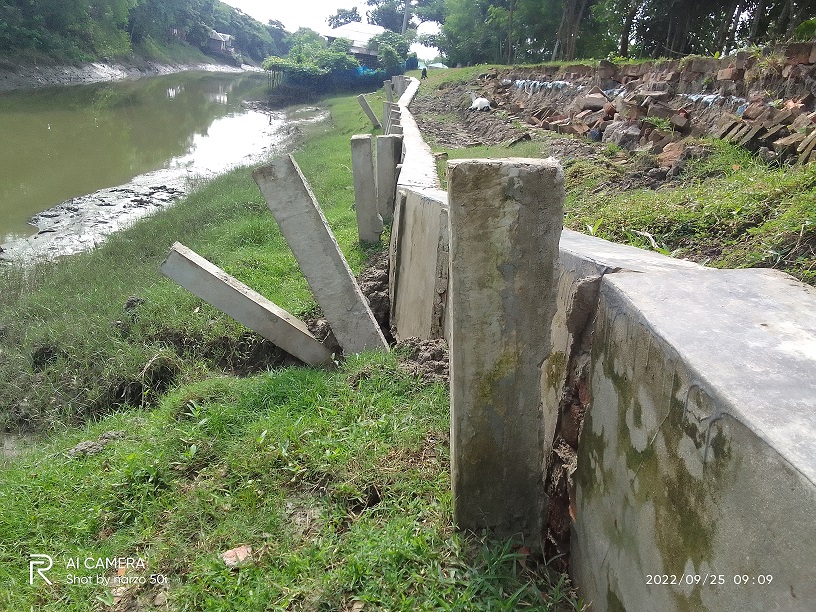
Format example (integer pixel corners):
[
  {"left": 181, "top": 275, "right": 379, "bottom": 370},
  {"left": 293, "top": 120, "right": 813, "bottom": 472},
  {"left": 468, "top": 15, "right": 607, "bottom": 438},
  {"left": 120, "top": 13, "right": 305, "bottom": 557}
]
[{"left": 572, "top": 269, "right": 816, "bottom": 611}]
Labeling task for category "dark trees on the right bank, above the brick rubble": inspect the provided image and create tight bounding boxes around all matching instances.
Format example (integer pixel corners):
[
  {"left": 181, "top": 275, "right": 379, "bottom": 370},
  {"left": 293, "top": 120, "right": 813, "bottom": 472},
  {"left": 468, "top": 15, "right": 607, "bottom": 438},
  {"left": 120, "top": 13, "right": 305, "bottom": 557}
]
[{"left": 436, "top": 0, "right": 816, "bottom": 64}]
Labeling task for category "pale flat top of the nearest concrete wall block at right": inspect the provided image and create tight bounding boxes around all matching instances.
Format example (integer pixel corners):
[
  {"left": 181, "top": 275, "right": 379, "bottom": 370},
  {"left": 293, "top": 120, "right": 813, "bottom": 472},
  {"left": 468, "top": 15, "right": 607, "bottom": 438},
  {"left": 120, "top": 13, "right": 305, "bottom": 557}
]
[{"left": 602, "top": 268, "right": 816, "bottom": 484}]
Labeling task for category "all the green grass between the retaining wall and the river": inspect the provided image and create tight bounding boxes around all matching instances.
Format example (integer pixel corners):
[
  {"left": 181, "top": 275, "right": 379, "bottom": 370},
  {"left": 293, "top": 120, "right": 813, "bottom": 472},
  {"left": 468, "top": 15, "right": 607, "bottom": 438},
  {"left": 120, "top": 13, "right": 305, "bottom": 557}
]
[{"left": 0, "top": 89, "right": 588, "bottom": 610}]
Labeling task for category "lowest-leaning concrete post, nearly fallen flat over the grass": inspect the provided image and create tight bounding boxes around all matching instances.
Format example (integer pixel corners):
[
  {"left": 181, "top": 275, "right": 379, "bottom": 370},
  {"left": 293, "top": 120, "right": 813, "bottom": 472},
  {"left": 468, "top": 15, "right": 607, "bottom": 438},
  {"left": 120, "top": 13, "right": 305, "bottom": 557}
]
[{"left": 161, "top": 242, "right": 332, "bottom": 365}]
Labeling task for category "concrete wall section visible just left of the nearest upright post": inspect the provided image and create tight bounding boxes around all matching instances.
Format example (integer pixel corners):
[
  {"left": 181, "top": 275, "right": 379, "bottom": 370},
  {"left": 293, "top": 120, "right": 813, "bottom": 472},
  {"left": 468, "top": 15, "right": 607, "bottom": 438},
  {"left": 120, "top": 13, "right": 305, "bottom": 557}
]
[{"left": 389, "top": 189, "right": 449, "bottom": 340}]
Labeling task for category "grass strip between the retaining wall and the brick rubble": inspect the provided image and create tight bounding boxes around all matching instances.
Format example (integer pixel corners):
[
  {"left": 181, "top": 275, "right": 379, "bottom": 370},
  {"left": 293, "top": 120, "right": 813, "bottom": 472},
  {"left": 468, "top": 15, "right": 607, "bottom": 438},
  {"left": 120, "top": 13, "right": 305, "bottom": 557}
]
[{"left": 412, "top": 66, "right": 816, "bottom": 285}]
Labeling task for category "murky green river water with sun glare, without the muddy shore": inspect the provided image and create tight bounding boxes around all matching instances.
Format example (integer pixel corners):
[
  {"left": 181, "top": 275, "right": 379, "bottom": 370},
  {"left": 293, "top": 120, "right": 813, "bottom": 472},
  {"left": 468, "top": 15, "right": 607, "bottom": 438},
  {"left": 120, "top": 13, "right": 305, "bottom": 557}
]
[{"left": 0, "top": 73, "right": 268, "bottom": 242}]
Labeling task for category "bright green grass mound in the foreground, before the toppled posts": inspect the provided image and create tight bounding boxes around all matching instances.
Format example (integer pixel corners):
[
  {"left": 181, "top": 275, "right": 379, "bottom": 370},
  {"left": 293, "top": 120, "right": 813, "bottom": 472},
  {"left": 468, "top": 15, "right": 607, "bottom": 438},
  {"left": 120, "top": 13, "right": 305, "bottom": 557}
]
[{"left": 0, "top": 353, "right": 578, "bottom": 610}]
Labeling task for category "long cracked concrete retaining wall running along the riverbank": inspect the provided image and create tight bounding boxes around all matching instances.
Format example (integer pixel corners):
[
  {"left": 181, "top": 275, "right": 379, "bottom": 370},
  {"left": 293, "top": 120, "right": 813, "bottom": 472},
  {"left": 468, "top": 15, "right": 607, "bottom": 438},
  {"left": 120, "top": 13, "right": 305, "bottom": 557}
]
[{"left": 391, "top": 74, "right": 816, "bottom": 612}]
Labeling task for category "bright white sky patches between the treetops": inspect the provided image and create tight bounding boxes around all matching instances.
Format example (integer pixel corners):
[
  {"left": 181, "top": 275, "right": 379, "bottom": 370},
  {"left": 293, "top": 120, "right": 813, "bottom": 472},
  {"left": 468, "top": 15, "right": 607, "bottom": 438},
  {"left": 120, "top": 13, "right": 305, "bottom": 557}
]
[{"left": 222, "top": 0, "right": 436, "bottom": 59}]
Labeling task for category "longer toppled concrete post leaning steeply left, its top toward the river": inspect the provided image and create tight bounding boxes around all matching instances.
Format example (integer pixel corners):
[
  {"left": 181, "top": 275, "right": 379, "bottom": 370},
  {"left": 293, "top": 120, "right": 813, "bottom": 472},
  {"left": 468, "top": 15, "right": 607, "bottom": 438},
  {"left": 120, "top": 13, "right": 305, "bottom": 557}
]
[{"left": 252, "top": 155, "right": 388, "bottom": 353}]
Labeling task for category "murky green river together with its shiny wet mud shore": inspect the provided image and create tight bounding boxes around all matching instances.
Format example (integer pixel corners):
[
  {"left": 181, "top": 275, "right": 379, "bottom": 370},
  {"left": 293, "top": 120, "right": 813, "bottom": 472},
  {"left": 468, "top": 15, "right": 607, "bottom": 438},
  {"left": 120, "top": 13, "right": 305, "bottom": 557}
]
[{"left": 0, "top": 72, "right": 319, "bottom": 259}]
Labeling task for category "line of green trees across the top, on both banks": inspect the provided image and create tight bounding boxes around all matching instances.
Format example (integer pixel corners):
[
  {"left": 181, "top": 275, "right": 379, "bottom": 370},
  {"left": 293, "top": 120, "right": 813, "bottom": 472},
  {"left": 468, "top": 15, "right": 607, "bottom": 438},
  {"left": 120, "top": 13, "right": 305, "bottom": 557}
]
[{"left": 0, "top": 0, "right": 816, "bottom": 65}]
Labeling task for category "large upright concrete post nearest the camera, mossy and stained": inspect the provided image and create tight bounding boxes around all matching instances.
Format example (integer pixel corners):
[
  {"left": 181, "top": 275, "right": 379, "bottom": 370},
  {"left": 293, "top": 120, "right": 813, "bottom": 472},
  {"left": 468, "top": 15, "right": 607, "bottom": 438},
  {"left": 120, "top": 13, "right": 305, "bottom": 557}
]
[{"left": 448, "top": 159, "right": 564, "bottom": 546}]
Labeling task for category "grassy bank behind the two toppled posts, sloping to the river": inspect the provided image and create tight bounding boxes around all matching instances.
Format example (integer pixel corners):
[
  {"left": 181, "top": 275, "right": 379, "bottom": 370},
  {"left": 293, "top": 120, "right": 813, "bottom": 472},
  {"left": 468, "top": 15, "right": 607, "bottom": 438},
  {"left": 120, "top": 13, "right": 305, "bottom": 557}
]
[{"left": 0, "top": 93, "right": 374, "bottom": 429}]
